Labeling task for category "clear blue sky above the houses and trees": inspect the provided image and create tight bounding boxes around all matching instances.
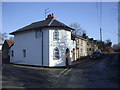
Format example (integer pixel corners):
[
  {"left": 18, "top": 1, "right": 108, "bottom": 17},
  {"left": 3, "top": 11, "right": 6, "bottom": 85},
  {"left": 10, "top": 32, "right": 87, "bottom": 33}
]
[{"left": 2, "top": 2, "right": 118, "bottom": 44}]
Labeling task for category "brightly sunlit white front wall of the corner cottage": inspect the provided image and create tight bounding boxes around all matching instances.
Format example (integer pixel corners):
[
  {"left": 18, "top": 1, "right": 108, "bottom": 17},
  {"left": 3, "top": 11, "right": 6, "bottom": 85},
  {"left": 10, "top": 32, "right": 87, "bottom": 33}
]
[{"left": 49, "top": 28, "right": 74, "bottom": 67}]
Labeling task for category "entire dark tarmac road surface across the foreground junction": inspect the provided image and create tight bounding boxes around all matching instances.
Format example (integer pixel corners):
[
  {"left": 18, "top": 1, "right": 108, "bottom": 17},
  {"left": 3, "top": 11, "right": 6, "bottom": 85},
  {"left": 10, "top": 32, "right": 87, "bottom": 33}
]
[{"left": 2, "top": 54, "right": 120, "bottom": 88}]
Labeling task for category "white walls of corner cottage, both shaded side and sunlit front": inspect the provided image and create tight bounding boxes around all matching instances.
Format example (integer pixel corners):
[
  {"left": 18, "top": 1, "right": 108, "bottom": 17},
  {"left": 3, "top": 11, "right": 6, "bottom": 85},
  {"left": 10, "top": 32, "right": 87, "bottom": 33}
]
[{"left": 10, "top": 28, "right": 76, "bottom": 67}]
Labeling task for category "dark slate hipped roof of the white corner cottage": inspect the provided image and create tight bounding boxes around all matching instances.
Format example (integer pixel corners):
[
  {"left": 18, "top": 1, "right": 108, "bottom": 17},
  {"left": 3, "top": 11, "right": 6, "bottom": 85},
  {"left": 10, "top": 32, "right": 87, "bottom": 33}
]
[{"left": 10, "top": 17, "right": 74, "bottom": 35}]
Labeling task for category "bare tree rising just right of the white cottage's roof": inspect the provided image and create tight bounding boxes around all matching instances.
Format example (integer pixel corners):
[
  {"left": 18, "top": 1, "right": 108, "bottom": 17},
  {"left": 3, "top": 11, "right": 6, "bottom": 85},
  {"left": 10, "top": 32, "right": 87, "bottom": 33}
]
[{"left": 70, "top": 23, "right": 86, "bottom": 35}]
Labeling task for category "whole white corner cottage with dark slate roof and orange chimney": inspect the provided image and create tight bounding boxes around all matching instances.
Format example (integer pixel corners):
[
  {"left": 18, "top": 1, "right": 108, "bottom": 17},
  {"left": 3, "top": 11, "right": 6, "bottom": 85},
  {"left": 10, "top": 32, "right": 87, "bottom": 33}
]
[{"left": 10, "top": 14, "right": 76, "bottom": 67}]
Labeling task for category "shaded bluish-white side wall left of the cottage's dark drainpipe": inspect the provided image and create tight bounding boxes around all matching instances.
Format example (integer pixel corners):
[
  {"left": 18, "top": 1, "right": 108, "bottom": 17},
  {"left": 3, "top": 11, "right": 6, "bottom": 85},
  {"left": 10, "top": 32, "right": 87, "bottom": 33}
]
[{"left": 10, "top": 31, "right": 42, "bottom": 66}]
